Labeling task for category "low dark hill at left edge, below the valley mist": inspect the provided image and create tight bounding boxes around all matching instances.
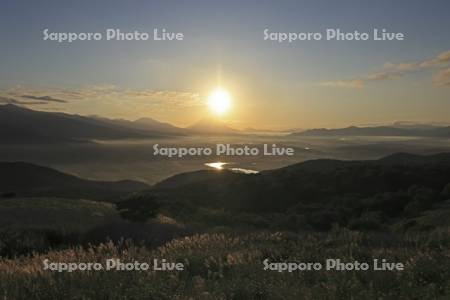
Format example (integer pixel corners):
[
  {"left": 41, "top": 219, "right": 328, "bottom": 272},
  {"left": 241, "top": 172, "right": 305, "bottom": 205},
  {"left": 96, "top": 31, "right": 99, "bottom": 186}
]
[{"left": 0, "top": 162, "right": 148, "bottom": 202}]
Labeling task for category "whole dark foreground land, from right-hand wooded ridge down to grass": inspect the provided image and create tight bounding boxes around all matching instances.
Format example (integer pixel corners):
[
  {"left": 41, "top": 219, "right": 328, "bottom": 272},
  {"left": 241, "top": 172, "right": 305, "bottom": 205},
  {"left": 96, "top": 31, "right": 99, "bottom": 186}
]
[{"left": 0, "top": 154, "right": 450, "bottom": 299}]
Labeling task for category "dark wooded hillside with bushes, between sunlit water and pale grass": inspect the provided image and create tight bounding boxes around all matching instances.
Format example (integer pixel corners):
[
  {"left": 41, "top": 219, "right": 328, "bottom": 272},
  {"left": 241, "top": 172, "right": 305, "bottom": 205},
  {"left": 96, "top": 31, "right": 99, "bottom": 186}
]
[{"left": 118, "top": 153, "right": 450, "bottom": 232}]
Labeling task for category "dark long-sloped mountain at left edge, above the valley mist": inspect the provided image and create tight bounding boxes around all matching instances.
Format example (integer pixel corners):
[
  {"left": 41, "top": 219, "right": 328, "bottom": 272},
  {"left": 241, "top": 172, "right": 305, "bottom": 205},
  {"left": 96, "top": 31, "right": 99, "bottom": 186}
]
[{"left": 0, "top": 104, "right": 182, "bottom": 143}]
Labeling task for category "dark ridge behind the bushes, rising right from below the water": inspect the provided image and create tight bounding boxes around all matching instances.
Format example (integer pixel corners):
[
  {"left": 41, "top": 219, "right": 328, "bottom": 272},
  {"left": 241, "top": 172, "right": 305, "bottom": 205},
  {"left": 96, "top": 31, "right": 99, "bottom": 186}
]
[{"left": 135, "top": 153, "right": 450, "bottom": 212}]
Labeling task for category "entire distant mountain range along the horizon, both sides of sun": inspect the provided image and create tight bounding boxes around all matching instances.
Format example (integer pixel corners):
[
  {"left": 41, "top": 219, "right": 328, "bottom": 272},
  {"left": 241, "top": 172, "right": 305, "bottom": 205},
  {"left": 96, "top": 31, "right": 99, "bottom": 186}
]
[{"left": 0, "top": 104, "right": 450, "bottom": 143}]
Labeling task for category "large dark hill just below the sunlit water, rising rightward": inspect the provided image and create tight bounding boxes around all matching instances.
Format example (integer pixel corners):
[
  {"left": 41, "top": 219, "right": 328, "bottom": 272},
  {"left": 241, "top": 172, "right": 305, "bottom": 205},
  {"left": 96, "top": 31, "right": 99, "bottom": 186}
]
[{"left": 122, "top": 153, "right": 450, "bottom": 222}]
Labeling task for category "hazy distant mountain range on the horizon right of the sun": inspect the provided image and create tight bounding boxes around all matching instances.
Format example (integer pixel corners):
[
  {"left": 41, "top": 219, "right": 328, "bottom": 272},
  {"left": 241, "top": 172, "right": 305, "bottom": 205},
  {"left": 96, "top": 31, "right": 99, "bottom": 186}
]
[{"left": 291, "top": 125, "right": 450, "bottom": 137}]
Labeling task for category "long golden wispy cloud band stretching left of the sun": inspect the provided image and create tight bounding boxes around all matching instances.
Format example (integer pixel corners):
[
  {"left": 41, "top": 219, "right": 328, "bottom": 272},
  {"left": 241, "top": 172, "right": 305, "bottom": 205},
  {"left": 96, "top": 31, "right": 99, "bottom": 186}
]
[{"left": 0, "top": 85, "right": 204, "bottom": 115}]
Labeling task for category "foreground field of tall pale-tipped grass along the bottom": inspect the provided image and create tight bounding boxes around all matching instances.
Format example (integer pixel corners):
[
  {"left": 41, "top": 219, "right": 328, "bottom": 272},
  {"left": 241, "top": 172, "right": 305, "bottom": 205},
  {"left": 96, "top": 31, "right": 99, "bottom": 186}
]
[{"left": 0, "top": 228, "right": 450, "bottom": 299}]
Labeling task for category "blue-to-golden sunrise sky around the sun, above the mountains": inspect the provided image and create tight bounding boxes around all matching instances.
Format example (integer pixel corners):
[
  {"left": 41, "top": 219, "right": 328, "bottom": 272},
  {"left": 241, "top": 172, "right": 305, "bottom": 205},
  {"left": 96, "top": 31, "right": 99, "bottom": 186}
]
[{"left": 0, "top": 0, "right": 450, "bottom": 129}]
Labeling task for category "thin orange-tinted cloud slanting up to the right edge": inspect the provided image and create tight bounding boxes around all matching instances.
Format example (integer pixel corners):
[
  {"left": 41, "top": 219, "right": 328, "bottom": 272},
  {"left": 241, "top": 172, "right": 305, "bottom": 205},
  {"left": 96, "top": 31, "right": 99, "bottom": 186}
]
[{"left": 323, "top": 51, "right": 450, "bottom": 87}]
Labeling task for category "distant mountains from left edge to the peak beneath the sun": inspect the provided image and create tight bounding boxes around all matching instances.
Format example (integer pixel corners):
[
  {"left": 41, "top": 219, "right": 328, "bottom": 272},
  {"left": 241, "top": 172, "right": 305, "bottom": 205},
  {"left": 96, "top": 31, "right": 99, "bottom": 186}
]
[{"left": 0, "top": 104, "right": 243, "bottom": 143}]
